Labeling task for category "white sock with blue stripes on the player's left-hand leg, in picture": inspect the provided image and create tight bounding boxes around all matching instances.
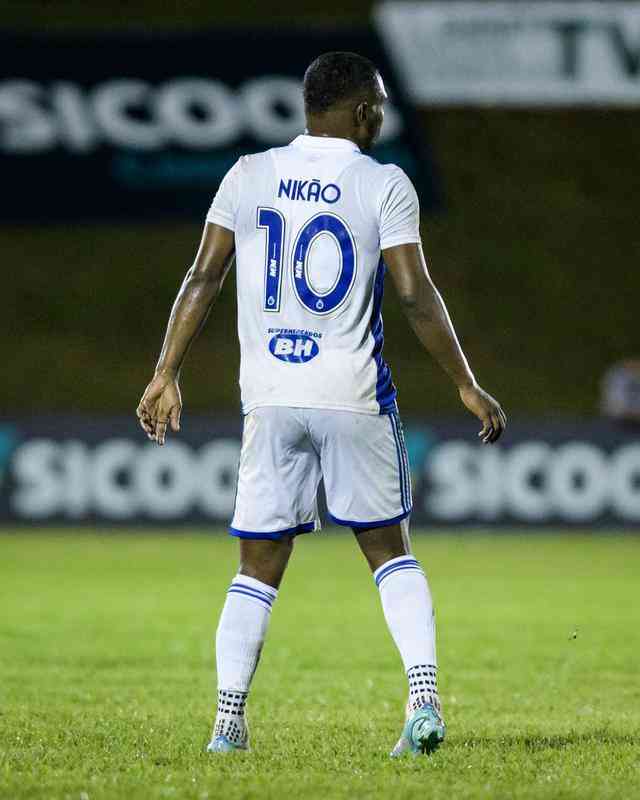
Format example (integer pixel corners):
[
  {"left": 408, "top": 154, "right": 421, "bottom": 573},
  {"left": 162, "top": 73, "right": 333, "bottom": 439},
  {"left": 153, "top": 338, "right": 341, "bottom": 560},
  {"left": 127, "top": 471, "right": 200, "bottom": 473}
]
[{"left": 213, "top": 574, "right": 278, "bottom": 744}]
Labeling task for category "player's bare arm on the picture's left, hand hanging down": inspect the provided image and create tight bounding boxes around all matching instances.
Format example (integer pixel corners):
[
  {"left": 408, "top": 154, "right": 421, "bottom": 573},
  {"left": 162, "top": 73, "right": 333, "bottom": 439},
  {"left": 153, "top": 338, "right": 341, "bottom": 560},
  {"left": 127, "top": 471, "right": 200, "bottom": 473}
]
[{"left": 137, "top": 222, "right": 235, "bottom": 445}]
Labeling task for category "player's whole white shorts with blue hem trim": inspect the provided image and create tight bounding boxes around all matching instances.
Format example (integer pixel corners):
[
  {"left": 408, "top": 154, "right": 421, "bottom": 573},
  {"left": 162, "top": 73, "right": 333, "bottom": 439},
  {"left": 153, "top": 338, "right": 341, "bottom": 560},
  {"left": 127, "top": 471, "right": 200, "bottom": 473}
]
[{"left": 229, "top": 406, "right": 411, "bottom": 539}]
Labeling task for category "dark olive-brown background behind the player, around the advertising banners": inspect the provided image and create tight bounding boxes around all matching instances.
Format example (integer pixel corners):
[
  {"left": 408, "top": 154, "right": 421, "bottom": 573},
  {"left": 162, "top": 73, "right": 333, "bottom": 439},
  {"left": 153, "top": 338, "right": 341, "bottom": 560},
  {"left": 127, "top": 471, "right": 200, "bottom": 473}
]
[{"left": 0, "top": 2, "right": 640, "bottom": 416}]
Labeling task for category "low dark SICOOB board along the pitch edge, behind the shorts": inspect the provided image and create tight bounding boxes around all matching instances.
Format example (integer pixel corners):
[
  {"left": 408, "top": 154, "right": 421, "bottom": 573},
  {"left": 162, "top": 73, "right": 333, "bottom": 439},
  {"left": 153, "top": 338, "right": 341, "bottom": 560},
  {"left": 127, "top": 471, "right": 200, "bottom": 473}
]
[{"left": 0, "top": 416, "right": 640, "bottom": 528}]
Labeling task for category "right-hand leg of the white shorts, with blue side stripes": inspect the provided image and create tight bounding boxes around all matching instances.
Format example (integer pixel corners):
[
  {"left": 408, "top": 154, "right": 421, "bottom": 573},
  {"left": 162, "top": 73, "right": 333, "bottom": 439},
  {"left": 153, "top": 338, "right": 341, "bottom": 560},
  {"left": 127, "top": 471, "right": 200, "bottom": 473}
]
[{"left": 311, "top": 411, "right": 411, "bottom": 529}]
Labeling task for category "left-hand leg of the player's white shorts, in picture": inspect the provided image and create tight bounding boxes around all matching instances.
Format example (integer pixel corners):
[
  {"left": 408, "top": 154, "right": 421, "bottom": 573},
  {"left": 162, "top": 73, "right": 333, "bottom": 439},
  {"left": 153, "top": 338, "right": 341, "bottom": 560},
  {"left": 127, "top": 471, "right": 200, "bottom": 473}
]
[{"left": 230, "top": 406, "right": 320, "bottom": 540}]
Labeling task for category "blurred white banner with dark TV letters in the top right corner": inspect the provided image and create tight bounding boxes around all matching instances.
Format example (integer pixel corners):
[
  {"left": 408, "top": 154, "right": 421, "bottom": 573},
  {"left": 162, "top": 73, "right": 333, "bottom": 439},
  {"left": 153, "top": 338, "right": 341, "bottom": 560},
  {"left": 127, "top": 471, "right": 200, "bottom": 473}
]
[{"left": 375, "top": 0, "right": 640, "bottom": 106}]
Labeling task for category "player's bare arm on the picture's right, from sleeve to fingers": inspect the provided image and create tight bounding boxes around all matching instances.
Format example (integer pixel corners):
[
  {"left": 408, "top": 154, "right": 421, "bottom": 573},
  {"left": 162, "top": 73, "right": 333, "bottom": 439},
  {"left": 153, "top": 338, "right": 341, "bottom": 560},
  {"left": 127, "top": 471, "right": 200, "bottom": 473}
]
[{"left": 382, "top": 243, "right": 507, "bottom": 443}]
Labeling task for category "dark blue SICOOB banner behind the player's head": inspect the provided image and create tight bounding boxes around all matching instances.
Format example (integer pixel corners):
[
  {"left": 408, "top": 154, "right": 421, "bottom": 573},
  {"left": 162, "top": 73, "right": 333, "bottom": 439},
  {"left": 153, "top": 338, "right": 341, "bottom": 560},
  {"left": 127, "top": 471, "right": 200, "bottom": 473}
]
[{"left": 0, "top": 28, "right": 438, "bottom": 222}]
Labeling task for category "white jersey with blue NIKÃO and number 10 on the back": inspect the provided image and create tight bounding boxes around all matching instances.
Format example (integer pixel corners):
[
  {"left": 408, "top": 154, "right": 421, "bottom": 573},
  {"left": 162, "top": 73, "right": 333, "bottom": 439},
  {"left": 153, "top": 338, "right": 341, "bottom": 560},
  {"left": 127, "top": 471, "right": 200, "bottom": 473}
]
[{"left": 207, "top": 135, "right": 420, "bottom": 414}]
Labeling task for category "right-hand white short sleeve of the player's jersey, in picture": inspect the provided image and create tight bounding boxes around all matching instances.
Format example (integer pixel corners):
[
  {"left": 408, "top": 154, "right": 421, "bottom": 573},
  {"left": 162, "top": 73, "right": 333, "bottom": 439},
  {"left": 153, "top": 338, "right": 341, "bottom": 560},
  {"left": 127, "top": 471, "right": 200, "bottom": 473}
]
[{"left": 380, "top": 167, "right": 420, "bottom": 250}]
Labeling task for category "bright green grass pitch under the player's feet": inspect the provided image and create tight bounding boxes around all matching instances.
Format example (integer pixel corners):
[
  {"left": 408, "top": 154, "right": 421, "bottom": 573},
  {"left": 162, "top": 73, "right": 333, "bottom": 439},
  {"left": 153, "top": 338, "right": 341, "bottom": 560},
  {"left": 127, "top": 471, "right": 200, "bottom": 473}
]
[{"left": 0, "top": 532, "right": 640, "bottom": 800}]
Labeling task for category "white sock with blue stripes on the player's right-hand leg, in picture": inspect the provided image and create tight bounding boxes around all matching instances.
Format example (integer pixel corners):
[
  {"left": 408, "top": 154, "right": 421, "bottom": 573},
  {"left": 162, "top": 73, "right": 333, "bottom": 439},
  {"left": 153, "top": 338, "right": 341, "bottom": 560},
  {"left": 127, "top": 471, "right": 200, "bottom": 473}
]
[{"left": 373, "top": 556, "right": 440, "bottom": 710}]
